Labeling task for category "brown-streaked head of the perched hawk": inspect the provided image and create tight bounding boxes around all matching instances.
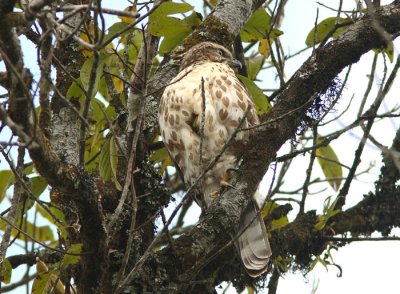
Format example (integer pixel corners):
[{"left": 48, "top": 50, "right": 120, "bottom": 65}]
[{"left": 180, "top": 42, "right": 242, "bottom": 70}]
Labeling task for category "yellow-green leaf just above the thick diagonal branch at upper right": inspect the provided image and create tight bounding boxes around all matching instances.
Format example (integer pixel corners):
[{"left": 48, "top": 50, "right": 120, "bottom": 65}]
[{"left": 306, "top": 17, "right": 352, "bottom": 47}]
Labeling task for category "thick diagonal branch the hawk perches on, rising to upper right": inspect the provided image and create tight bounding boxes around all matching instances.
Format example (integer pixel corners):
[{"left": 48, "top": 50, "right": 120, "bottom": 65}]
[{"left": 133, "top": 1, "right": 400, "bottom": 287}]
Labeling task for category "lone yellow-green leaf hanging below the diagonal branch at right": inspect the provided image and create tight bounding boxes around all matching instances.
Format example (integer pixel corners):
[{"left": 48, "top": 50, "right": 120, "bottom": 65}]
[{"left": 316, "top": 137, "right": 343, "bottom": 191}]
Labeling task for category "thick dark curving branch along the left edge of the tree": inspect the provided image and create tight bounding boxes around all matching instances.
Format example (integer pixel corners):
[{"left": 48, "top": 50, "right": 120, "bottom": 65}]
[{"left": 0, "top": 1, "right": 108, "bottom": 293}]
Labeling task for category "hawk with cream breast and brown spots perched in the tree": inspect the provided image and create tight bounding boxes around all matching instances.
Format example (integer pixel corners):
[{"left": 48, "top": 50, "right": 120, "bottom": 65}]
[{"left": 159, "top": 42, "right": 272, "bottom": 277}]
